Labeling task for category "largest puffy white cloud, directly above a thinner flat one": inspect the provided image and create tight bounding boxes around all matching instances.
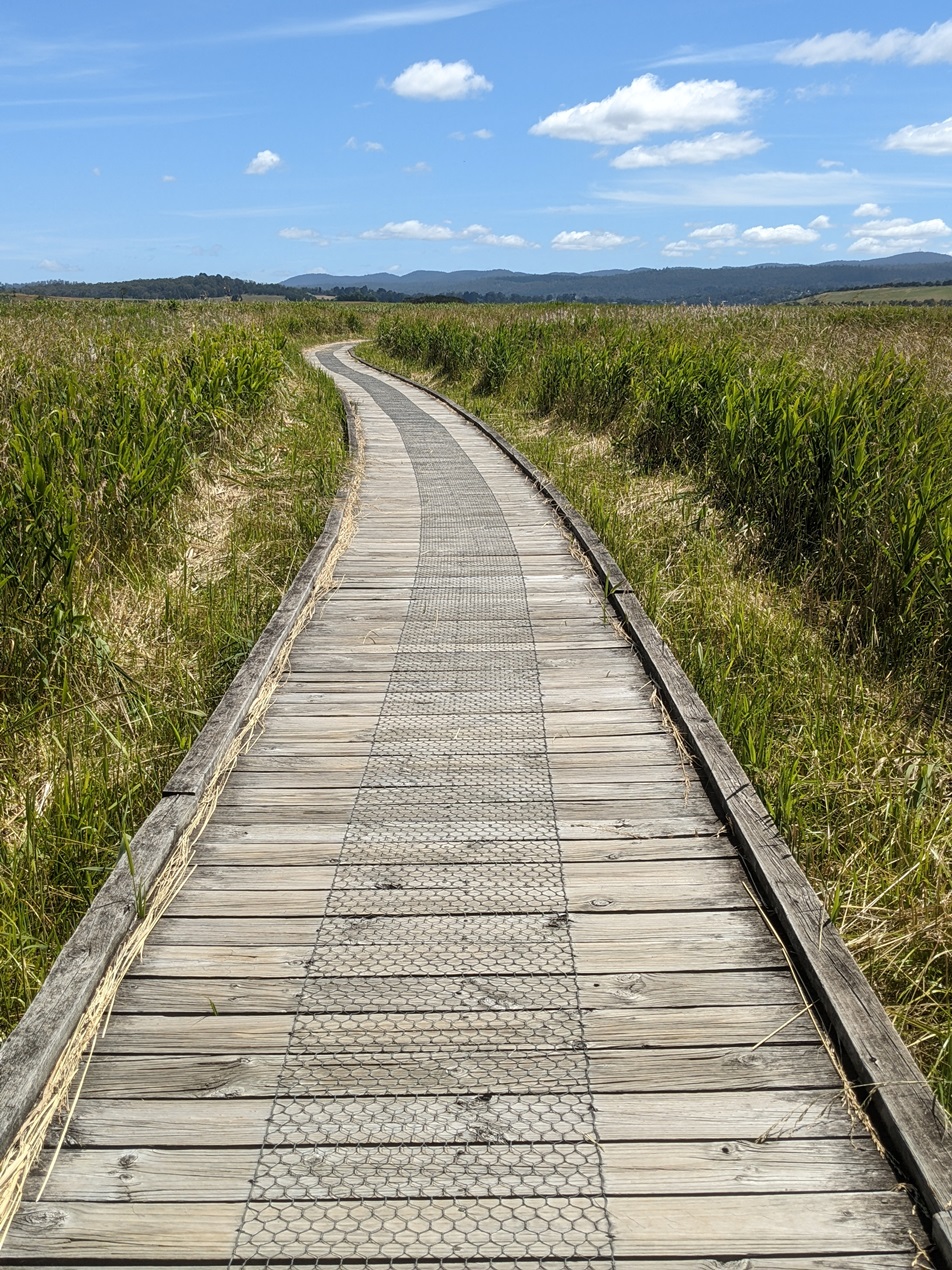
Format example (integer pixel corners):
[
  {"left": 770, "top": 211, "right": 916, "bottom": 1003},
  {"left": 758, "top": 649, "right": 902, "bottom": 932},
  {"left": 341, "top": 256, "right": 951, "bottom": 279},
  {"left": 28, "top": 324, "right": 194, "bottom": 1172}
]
[{"left": 529, "top": 75, "right": 764, "bottom": 145}]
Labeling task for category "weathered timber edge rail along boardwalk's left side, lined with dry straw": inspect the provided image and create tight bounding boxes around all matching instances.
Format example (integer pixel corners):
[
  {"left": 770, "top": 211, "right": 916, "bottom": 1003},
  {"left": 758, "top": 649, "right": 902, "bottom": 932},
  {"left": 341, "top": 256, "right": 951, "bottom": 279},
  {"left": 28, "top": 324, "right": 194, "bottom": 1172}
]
[{"left": 0, "top": 378, "right": 362, "bottom": 1229}]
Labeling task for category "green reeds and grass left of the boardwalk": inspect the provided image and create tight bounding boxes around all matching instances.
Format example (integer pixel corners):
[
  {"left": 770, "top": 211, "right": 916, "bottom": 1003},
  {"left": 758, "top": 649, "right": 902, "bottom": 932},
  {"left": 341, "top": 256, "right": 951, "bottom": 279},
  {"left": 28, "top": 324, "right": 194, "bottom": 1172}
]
[{"left": 0, "top": 301, "right": 360, "bottom": 1034}]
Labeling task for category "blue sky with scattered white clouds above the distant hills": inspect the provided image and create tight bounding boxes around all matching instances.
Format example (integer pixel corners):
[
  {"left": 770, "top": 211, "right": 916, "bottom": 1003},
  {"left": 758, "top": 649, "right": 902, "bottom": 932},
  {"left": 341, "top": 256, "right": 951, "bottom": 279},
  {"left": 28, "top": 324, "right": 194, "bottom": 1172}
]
[{"left": 0, "top": 0, "right": 952, "bottom": 282}]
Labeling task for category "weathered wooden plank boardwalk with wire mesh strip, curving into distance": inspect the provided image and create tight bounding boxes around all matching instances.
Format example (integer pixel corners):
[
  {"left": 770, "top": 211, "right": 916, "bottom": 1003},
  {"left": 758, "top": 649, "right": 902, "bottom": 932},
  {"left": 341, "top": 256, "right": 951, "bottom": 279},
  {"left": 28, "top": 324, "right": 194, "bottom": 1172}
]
[{"left": 0, "top": 349, "right": 928, "bottom": 1270}]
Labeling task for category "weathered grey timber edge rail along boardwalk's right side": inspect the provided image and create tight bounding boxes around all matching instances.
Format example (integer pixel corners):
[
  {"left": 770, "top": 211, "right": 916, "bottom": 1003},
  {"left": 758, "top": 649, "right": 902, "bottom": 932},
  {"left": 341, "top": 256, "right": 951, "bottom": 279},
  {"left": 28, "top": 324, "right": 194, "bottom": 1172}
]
[{"left": 352, "top": 351, "right": 952, "bottom": 1270}]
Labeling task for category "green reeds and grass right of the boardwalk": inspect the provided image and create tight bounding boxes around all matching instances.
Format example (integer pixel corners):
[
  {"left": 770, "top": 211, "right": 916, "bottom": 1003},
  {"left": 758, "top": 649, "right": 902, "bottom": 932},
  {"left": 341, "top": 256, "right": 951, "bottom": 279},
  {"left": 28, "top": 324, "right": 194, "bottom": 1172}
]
[{"left": 371, "top": 306, "right": 952, "bottom": 1106}]
